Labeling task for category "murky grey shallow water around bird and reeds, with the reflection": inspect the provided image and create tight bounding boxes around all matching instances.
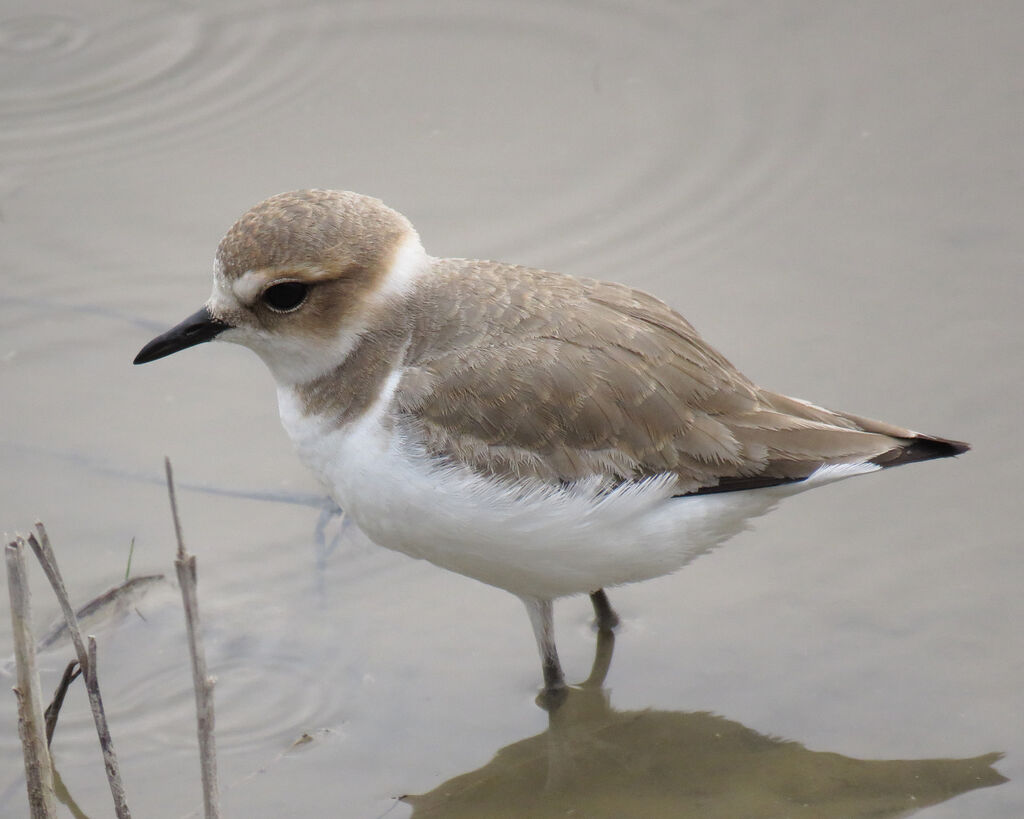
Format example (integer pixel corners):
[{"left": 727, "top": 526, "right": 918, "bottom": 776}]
[{"left": 0, "top": 0, "right": 1024, "bottom": 817}]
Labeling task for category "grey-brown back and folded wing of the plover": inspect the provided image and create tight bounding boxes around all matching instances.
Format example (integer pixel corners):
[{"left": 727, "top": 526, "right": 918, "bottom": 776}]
[{"left": 395, "top": 260, "right": 962, "bottom": 493}]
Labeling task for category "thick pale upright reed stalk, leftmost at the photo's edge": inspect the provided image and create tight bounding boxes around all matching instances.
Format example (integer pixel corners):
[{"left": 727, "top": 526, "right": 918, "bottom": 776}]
[{"left": 5, "top": 537, "right": 57, "bottom": 819}]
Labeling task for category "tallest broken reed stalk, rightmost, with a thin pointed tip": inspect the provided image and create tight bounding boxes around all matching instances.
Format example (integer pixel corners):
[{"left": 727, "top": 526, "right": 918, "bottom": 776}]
[{"left": 164, "top": 458, "right": 220, "bottom": 819}]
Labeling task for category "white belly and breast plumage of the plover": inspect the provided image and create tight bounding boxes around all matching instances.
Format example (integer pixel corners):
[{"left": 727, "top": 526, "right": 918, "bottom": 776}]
[{"left": 279, "top": 389, "right": 876, "bottom": 599}]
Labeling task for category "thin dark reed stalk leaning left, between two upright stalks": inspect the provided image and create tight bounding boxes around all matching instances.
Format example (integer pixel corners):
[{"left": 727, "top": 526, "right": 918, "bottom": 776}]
[{"left": 29, "top": 521, "right": 131, "bottom": 819}]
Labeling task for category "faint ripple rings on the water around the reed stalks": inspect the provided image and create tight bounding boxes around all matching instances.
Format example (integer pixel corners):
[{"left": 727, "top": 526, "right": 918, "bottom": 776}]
[{"left": 29, "top": 588, "right": 357, "bottom": 756}]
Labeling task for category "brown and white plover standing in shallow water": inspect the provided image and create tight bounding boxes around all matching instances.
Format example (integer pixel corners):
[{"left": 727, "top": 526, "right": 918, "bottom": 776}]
[{"left": 134, "top": 189, "right": 970, "bottom": 701}]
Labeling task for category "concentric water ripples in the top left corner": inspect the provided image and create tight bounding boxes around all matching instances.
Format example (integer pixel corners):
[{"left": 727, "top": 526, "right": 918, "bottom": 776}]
[{"left": 0, "top": 0, "right": 333, "bottom": 175}]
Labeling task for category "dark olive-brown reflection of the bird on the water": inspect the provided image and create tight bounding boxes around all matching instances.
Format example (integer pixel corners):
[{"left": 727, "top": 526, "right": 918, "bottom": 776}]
[{"left": 403, "top": 632, "right": 1007, "bottom": 819}]
